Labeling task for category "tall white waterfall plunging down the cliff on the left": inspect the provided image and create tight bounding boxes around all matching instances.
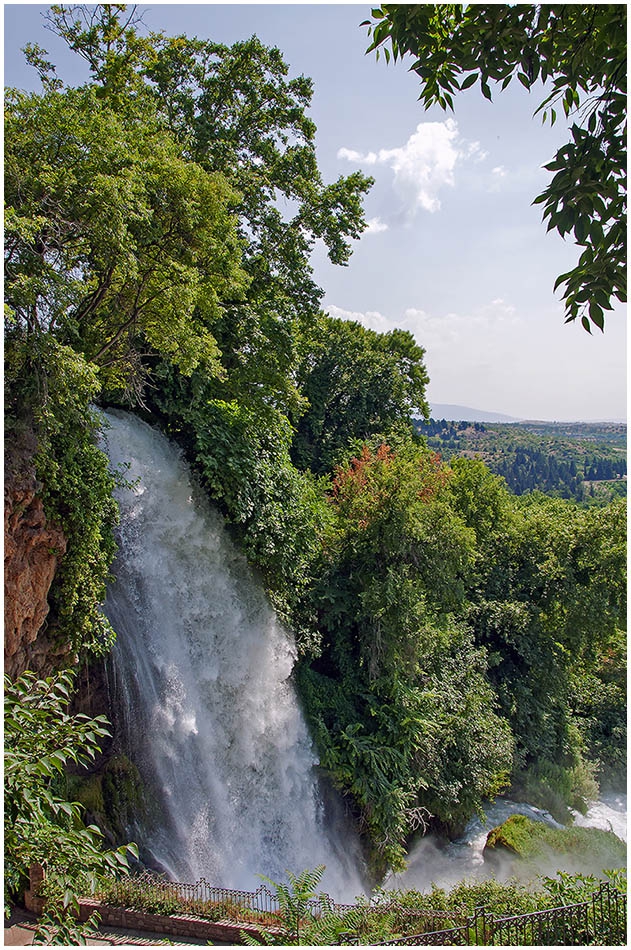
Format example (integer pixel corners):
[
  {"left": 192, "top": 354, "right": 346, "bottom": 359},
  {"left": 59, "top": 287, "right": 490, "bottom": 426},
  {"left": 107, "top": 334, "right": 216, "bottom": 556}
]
[{"left": 99, "top": 413, "right": 363, "bottom": 900}]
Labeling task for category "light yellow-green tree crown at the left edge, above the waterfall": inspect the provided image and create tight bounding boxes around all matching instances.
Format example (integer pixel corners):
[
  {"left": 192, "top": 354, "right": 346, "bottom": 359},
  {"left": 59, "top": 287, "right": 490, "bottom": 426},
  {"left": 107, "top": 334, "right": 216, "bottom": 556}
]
[{"left": 5, "top": 77, "right": 246, "bottom": 398}]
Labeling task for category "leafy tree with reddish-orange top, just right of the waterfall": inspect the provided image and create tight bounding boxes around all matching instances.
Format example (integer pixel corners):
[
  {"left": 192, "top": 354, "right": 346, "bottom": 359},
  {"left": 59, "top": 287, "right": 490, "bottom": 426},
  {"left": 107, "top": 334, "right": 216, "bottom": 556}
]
[{"left": 300, "top": 439, "right": 512, "bottom": 873}]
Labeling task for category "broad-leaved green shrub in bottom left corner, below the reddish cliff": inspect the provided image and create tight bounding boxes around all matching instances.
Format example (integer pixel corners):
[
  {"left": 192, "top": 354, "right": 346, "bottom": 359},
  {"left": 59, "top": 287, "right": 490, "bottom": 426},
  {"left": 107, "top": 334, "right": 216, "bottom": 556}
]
[{"left": 4, "top": 671, "right": 138, "bottom": 940}]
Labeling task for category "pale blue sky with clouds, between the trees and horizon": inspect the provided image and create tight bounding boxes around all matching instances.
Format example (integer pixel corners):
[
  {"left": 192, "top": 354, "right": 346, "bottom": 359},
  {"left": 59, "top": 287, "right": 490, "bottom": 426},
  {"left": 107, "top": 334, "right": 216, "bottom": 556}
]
[{"left": 4, "top": 3, "right": 627, "bottom": 421}]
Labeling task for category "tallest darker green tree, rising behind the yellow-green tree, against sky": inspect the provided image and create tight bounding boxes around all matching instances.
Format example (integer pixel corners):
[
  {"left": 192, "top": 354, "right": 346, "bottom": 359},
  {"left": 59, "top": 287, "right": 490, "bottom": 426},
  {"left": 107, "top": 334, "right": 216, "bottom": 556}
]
[{"left": 43, "top": 4, "right": 371, "bottom": 415}]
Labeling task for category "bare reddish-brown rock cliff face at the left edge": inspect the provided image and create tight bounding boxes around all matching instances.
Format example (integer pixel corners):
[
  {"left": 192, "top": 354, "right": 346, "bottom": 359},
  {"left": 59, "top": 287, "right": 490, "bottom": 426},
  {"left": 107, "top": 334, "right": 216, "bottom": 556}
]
[{"left": 4, "top": 459, "right": 68, "bottom": 678}]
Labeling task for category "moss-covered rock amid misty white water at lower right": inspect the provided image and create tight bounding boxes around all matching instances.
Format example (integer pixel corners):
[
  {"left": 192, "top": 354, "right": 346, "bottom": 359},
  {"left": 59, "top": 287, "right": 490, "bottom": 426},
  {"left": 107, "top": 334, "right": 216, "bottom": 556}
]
[{"left": 484, "top": 815, "right": 626, "bottom": 874}]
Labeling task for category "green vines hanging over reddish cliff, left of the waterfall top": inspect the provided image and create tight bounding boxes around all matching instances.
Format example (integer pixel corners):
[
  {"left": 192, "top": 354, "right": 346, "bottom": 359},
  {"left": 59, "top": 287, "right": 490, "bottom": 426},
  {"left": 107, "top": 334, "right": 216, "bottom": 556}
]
[{"left": 5, "top": 334, "right": 118, "bottom": 655}]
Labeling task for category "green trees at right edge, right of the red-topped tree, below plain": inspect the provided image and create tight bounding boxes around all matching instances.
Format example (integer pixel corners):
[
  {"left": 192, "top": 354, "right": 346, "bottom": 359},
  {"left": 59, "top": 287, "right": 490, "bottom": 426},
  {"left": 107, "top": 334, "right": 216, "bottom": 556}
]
[{"left": 449, "top": 459, "right": 626, "bottom": 816}]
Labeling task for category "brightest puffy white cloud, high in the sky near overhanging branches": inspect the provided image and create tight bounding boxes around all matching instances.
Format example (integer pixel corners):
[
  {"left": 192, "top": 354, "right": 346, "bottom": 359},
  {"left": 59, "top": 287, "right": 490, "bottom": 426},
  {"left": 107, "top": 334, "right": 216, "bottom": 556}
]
[{"left": 337, "top": 119, "right": 487, "bottom": 218}]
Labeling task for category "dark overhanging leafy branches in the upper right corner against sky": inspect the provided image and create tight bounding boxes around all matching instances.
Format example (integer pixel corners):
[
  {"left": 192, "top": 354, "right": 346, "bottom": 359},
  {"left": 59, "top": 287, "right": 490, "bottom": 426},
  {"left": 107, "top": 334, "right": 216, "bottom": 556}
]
[{"left": 364, "top": 4, "right": 627, "bottom": 332}]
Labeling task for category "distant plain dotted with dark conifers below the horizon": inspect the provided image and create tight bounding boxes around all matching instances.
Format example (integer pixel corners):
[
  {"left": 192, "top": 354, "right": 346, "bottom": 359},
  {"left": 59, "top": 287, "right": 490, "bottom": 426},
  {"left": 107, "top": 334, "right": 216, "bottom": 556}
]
[{"left": 414, "top": 419, "right": 627, "bottom": 505}]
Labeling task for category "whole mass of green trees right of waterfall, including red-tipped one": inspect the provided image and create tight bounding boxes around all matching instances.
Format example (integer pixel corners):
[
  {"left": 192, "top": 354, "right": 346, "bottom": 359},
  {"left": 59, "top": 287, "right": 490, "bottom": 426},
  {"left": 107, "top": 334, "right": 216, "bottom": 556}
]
[{"left": 299, "top": 442, "right": 625, "bottom": 873}]
